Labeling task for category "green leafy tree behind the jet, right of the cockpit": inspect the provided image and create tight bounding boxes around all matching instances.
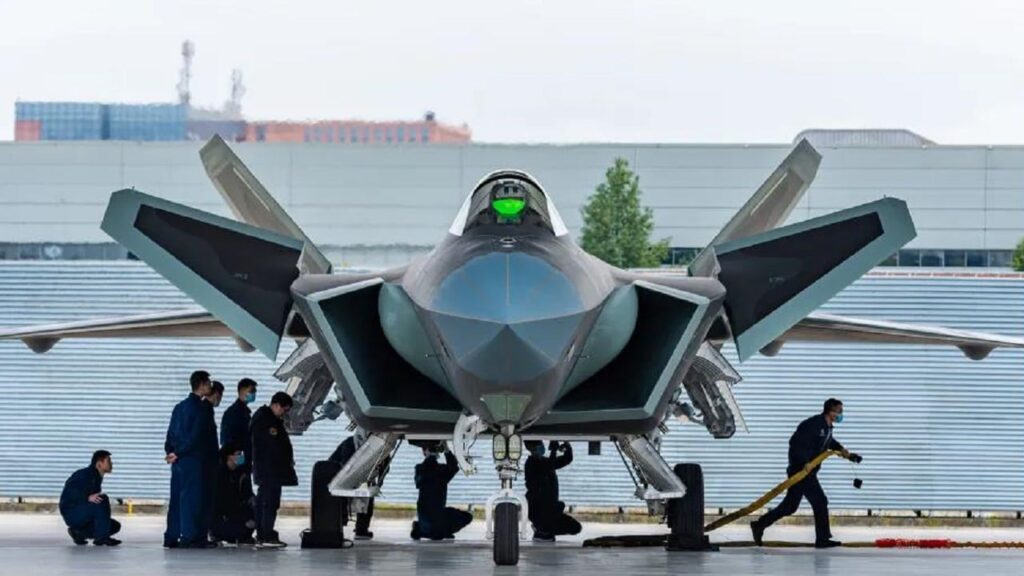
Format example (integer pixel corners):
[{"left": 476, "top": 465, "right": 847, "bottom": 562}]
[{"left": 580, "top": 158, "right": 669, "bottom": 268}]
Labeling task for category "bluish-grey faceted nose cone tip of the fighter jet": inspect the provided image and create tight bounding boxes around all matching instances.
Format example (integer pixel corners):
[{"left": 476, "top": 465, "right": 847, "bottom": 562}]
[{"left": 431, "top": 253, "right": 584, "bottom": 381}]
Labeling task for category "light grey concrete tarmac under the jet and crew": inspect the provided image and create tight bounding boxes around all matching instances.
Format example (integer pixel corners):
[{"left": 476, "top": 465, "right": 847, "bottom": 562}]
[{"left": 0, "top": 513, "right": 1024, "bottom": 576}]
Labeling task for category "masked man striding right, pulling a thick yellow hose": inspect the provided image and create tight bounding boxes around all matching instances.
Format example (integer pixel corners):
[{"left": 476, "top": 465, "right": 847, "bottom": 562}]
[{"left": 751, "top": 398, "right": 862, "bottom": 548}]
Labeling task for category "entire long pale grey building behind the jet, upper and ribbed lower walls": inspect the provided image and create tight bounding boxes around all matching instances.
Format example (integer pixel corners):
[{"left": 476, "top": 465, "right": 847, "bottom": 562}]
[{"left": 0, "top": 132, "right": 1024, "bottom": 511}]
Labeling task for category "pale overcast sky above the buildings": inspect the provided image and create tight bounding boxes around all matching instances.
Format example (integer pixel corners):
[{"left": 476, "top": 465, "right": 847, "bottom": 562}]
[{"left": 0, "top": 0, "right": 1024, "bottom": 143}]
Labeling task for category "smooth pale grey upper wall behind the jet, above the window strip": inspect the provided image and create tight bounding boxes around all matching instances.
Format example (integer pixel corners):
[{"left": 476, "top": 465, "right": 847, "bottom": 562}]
[{"left": 0, "top": 141, "right": 1024, "bottom": 250}]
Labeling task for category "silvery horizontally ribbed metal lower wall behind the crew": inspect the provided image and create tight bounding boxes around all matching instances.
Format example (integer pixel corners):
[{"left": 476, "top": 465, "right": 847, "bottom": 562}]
[{"left": 0, "top": 261, "right": 1024, "bottom": 510}]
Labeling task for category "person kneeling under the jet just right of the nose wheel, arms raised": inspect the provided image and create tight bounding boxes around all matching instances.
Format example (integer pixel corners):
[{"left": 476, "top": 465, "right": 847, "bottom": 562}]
[{"left": 525, "top": 441, "right": 582, "bottom": 542}]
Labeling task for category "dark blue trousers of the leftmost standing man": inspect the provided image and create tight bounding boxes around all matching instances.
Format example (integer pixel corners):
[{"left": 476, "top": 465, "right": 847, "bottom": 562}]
[{"left": 164, "top": 458, "right": 209, "bottom": 544}]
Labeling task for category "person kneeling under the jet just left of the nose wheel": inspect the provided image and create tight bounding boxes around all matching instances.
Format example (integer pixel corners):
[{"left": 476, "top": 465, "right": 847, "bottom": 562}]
[{"left": 410, "top": 443, "right": 473, "bottom": 540}]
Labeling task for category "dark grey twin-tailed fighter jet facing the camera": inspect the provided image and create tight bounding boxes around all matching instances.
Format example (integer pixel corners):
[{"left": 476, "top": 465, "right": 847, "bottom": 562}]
[{"left": 0, "top": 137, "right": 1024, "bottom": 565}]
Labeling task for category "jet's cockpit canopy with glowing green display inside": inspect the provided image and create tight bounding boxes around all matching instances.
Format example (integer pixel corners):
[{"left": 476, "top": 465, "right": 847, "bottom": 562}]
[{"left": 449, "top": 170, "right": 568, "bottom": 236}]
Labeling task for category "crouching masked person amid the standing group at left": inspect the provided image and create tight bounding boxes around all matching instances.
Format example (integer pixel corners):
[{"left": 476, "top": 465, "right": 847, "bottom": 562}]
[{"left": 210, "top": 445, "right": 256, "bottom": 544}]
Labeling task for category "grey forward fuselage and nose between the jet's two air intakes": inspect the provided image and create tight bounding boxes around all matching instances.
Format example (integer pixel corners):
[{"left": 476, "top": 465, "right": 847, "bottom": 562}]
[{"left": 399, "top": 225, "right": 616, "bottom": 425}]
